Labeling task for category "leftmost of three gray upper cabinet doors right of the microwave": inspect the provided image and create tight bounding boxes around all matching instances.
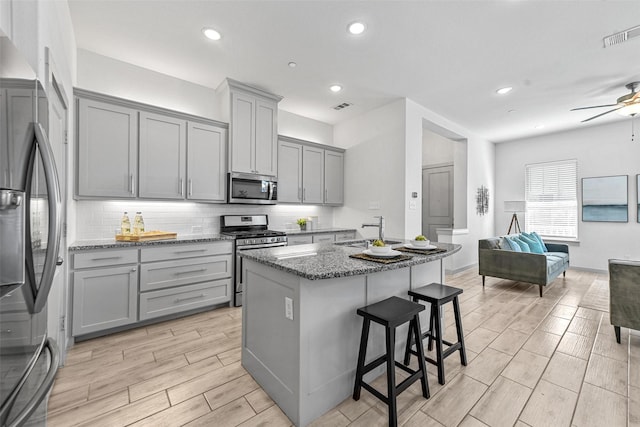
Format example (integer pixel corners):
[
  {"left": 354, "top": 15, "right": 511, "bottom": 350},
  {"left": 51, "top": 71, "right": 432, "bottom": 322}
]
[{"left": 278, "top": 141, "right": 302, "bottom": 203}]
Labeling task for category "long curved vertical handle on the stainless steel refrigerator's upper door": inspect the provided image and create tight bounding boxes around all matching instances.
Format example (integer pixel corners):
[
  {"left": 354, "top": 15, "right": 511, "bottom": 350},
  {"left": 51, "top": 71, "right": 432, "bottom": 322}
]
[{"left": 33, "top": 123, "right": 62, "bottom": 313}]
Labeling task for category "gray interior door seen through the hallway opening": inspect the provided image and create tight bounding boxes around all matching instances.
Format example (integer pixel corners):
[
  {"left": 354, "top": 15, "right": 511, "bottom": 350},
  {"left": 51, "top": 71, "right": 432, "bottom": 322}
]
[{"left": 422, "top": 165, "right": 453, "bottom": 242}]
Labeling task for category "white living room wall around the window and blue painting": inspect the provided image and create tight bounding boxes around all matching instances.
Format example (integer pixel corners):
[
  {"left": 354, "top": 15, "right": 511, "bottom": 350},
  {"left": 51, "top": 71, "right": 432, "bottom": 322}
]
[{"left": 495, "top": 119, "right": 640, "bottom": 271}]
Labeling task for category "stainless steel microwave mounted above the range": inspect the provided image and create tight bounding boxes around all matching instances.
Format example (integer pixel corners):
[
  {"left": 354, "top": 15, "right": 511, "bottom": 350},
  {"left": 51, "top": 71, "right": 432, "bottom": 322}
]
[{"left": 227, "top": 172, "right": 278, "bottom": 205}]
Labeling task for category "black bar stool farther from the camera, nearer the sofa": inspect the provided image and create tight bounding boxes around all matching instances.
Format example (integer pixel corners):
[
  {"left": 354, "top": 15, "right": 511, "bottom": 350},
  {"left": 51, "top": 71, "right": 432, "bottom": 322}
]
[{"left": 404, "top": 283, "right": 467, "bottom": 384}]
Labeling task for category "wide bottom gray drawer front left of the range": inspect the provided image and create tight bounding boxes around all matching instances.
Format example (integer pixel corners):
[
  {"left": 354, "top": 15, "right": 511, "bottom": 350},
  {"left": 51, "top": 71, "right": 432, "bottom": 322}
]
[{"left": 140, "top": 279, "right": 231, "bottom": 320}]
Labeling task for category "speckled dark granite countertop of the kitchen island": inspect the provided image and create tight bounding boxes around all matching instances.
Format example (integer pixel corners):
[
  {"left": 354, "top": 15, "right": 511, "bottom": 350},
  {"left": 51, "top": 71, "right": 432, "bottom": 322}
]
[{"left": 241, "top": 241, "right": 462, "bottom": 280}]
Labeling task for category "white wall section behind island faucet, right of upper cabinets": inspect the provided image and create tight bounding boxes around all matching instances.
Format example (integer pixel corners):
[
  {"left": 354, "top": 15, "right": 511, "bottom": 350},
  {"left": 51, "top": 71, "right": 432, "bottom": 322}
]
[{"left": 334, "top": 99, "right": 408, "bottom": 238}]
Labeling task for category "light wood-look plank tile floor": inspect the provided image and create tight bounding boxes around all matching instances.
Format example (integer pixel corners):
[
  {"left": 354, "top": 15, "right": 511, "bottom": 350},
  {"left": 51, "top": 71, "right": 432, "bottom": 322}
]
[{"left": 49, "top": 269, "right": 640, "bottom": 427}]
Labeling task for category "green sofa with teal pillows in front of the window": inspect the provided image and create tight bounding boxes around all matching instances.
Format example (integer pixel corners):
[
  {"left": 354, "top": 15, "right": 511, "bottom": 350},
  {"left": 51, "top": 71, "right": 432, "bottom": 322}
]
[{"left": 478, "top": 237, "right": 569, "bottom": 296}]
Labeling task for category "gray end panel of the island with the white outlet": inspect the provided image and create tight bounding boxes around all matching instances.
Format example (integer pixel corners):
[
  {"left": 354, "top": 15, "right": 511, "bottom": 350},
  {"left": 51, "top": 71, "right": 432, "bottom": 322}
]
[{"left": 242, "top": 260, "right": 300, "bottom": 425}]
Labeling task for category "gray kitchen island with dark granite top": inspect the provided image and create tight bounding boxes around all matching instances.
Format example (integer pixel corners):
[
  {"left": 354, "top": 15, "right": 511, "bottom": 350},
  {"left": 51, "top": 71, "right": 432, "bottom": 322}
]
[{"left": 242, "top": 243, "right": 461, "bottom": 426}]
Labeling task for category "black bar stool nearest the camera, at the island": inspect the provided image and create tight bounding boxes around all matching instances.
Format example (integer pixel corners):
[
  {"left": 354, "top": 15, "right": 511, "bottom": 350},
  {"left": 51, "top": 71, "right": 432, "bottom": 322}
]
[{"left": 353, "top": 297, "right": 429, "bottom": 427}]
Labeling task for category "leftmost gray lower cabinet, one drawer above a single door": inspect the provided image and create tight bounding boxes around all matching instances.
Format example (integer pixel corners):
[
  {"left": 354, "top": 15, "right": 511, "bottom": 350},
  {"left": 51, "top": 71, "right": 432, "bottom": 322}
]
[{"left": 72, "top": 249, "right": 138, "bottom": 336}]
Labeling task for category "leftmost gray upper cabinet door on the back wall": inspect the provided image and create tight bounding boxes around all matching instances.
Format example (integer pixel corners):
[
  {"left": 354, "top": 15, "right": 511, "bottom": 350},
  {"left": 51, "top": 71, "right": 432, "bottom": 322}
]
[{"left": 76, "top": 99, "right": 138, "bottom": 198}]
